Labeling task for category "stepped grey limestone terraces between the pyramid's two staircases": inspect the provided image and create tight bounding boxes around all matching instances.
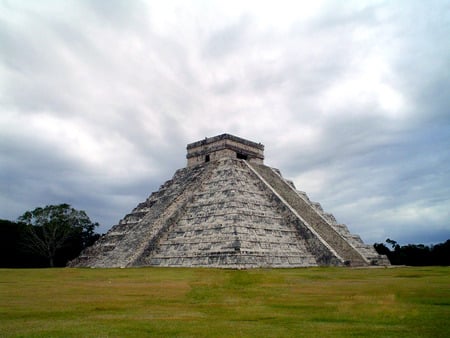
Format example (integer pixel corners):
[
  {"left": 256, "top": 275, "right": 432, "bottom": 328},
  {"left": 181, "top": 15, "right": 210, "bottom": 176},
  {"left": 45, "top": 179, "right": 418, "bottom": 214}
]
[{"left": 139, "top": 159, "right": 317, "bottom": 268}]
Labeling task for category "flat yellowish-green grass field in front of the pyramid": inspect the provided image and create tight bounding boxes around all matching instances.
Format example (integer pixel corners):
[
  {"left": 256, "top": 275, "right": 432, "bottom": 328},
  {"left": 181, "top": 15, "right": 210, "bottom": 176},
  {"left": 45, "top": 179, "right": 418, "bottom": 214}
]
[{"left": 0, "top": 267, "right": 450, "bottom": 337}]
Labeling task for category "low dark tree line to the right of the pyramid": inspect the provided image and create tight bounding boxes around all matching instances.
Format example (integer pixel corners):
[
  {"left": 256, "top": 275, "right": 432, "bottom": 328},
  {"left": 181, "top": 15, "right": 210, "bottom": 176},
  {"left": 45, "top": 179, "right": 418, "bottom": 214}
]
[{"left": 373, "top": 238, "right": 450, "bottom": 266}]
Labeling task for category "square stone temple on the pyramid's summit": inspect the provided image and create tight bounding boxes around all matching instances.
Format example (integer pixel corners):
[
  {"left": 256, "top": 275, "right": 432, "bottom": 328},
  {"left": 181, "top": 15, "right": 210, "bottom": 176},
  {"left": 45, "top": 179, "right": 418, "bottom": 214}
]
[{"left": 186, "top": 134, "right": 264, "bottom": 167}]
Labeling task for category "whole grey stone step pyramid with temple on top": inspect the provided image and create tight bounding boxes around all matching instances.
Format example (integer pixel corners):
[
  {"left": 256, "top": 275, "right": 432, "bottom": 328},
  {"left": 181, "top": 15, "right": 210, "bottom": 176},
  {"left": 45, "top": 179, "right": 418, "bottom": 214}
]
[{"left": 69, "top": 134, "right": 389, "bottom": 268}]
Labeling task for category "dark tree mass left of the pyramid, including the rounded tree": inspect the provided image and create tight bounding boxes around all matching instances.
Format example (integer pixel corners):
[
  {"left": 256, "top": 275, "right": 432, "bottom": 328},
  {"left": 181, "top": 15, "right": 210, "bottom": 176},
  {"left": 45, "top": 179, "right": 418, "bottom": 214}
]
[{"left": 0, "top": 204, "right": 100, "bottom": 268}]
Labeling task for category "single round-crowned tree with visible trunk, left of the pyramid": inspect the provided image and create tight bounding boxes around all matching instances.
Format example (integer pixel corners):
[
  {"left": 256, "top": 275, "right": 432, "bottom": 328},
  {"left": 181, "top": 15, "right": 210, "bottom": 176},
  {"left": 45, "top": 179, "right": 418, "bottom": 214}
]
[{"left": 19, "top": 204, "right": 98, "bottom": 267}]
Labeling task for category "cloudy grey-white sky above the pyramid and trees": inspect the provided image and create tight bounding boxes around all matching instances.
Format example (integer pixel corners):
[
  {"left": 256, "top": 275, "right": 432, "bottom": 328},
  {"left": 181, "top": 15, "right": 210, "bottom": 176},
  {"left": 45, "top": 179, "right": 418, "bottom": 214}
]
[{"left": 0, "top": 0, "right": 450, "bottom": 244}]
